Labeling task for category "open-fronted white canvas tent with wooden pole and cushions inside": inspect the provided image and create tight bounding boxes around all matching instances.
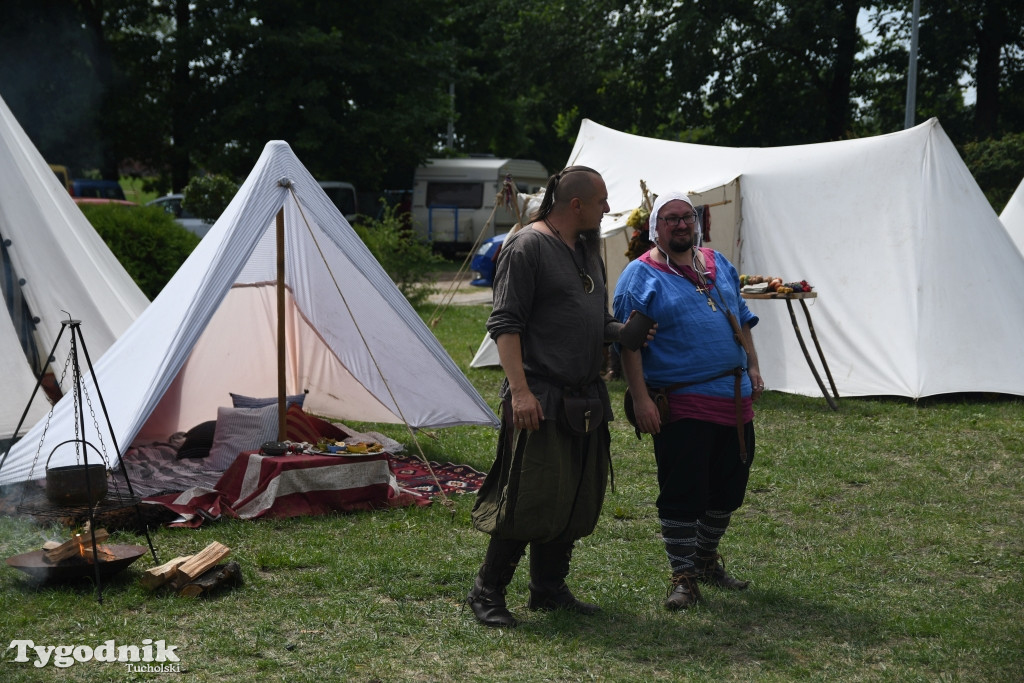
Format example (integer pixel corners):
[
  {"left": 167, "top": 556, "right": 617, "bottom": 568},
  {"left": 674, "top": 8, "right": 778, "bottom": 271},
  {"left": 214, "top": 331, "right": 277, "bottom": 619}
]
[{"left": 0, "top": 141, "right": 498, "bottom": 483}]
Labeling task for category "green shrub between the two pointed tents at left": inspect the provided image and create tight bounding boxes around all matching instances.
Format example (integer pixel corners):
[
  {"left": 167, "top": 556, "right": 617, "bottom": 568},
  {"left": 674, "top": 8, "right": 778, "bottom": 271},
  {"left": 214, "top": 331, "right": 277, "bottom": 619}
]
[{"left": 80, "top": 204, "right": 199, "bottom": 300}]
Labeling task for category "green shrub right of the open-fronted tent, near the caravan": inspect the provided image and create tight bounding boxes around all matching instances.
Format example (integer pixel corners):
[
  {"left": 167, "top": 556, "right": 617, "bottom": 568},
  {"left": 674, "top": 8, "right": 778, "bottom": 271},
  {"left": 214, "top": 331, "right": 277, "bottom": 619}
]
[{"left": 352, "top": 201, "right": 444, "bottom": 306}]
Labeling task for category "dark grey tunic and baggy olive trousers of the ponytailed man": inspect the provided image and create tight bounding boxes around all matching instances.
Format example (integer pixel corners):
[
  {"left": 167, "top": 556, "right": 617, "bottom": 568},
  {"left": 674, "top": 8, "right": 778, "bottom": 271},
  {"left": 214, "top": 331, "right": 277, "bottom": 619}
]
[{"left": 473, "top": 228, "right": 621, "bottom": 542}]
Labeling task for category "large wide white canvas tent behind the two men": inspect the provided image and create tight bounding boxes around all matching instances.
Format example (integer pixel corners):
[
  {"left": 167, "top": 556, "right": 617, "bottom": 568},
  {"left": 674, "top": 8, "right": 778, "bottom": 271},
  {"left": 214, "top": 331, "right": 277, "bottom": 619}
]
[{"left": 475, "top": 114, "right": 1024, "bottom": 398}]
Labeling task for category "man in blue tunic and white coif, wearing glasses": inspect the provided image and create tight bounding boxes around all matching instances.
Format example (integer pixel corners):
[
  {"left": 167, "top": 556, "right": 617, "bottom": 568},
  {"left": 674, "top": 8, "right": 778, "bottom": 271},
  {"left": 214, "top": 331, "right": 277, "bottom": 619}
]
[{"left": 613, "top": 193, "right": 764, "bottom": 609}]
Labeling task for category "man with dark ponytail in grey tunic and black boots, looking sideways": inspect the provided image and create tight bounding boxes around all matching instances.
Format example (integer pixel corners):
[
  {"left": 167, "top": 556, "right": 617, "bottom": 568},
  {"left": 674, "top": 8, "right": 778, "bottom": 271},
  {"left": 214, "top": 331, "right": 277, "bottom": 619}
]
[{"left": 467, "top": 166, "right": 622, "bottom": 627}]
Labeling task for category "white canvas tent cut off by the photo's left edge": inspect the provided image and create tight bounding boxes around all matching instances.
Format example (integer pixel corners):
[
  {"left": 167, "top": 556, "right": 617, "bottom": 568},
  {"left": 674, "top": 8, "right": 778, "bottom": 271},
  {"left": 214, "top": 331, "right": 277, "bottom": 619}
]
[{"left": 0, "top": 92, "right": 148, "bottom": 441}]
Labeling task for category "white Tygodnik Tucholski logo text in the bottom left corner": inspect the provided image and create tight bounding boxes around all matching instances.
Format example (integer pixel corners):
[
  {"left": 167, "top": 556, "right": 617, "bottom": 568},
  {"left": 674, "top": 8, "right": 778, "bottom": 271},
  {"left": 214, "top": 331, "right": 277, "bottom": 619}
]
[{"left": 7, "top": 638, "right": 181, "bottom": 673}]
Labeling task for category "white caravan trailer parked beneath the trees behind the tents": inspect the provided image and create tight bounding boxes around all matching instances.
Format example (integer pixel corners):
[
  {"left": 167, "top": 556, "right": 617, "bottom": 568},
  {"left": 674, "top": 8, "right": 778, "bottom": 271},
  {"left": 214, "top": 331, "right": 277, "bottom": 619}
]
[{"left": 413, "top": 157, "right": 548, "bottom": 256}]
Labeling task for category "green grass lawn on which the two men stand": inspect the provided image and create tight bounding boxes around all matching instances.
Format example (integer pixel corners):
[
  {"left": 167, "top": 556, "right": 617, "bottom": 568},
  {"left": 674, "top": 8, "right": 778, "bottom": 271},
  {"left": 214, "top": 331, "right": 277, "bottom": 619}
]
[{"left": 0, "top": 306, "right": 1024, "bottom": 682}]
